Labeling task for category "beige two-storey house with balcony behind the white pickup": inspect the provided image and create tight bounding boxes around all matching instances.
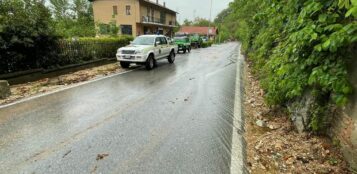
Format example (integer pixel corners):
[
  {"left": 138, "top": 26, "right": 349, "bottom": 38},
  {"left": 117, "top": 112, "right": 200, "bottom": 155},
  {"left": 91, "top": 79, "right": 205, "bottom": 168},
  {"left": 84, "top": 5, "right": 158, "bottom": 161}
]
[{"left": 93, "top": 0, "right": 177, "bottom": 37}]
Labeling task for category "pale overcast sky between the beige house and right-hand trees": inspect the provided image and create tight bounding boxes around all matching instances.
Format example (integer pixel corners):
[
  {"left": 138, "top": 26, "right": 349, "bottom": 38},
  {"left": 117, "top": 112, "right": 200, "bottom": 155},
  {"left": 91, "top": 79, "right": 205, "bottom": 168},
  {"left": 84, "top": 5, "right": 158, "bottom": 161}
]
[{"left": 151, "top": 0, "right": 233, "bottom": 23}]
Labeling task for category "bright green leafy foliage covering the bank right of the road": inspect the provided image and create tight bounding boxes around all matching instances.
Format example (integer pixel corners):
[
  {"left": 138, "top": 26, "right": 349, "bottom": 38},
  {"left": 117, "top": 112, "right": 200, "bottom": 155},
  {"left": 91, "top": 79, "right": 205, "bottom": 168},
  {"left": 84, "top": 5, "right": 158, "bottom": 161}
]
[{"left": 217, "top": 0, "right": 357, "bottom": 131}]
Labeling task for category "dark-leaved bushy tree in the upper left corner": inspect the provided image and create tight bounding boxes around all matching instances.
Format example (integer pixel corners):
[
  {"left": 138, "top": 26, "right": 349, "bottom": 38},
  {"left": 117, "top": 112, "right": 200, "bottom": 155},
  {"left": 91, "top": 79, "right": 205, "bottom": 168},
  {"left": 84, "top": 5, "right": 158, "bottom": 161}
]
[{"left": 0, "top": 0, "right": 57, "bottom": 73}]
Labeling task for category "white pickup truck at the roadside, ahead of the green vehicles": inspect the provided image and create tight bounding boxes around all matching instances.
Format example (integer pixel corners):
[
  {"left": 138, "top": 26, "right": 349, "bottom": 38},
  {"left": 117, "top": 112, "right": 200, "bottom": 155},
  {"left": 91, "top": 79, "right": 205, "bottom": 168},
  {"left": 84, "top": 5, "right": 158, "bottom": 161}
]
[{"left": 116, "top": 35, "right": 177, "bottom": 70}]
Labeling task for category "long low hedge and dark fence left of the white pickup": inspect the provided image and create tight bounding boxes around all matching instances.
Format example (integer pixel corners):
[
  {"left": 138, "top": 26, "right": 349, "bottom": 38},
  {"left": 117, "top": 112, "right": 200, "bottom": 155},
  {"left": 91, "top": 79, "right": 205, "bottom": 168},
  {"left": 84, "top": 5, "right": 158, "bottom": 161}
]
[{"left": 0, "top": 36, "right": 133, "bottom": 74}]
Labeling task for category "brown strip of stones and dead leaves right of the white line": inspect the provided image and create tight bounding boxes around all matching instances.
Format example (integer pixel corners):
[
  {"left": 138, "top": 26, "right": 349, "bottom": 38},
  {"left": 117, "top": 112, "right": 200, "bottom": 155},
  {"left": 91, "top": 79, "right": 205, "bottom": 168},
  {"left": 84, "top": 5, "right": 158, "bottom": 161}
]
[{"left": 244, "top": 61, "right": 351, "bottom": 174}]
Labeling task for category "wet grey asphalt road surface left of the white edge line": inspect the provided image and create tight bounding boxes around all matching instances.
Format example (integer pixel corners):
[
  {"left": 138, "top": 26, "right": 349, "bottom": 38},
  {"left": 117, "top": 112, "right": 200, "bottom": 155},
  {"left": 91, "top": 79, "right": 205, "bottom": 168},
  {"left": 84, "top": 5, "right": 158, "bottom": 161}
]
[{"left": 0, "top": 43, "right": 243, "bottom": 174}]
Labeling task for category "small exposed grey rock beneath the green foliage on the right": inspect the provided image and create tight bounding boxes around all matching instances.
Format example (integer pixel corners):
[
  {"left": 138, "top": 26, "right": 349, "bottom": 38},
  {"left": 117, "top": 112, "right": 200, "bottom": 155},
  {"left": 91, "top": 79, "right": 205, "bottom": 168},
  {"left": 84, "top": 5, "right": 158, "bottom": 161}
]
[{"left": 288, "top": 91, "right": 316, "bottom": 133}]
